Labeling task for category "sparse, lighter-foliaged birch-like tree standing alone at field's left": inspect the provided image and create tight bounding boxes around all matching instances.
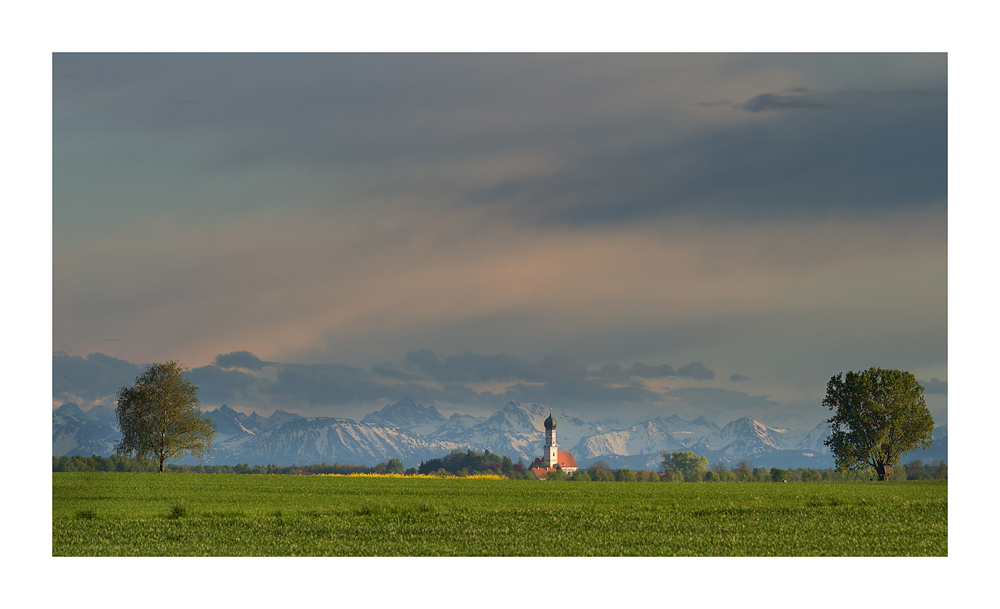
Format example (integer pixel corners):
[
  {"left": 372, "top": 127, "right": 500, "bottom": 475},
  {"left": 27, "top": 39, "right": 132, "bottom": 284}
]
[{"left": 115, "top": 360, "right": 215, "bottom": 473}]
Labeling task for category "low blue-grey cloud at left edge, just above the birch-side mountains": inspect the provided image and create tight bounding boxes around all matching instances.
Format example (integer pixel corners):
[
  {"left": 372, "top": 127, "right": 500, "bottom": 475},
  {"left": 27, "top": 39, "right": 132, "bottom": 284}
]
[{"left": 52, "top": 351, "right": 146, "bottom": 400}]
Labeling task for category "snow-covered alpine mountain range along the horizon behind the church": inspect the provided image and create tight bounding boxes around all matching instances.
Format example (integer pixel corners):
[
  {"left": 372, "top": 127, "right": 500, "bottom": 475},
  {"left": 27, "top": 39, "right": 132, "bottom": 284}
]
[{"left": 52, "top": 399, "right": 948, "bottom": 470}]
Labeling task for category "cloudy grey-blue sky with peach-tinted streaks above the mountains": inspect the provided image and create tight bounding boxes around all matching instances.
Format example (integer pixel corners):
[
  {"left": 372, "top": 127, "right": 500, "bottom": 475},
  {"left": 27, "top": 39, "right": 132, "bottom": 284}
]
[{"left": 52, "top": 53, "right": 948, "bottom": 427}]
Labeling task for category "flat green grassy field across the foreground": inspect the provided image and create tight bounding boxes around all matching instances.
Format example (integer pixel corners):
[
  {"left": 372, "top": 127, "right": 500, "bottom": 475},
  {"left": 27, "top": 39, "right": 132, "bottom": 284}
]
[{"left": 52, "top": 473, "right": 948, "bottom": 556}]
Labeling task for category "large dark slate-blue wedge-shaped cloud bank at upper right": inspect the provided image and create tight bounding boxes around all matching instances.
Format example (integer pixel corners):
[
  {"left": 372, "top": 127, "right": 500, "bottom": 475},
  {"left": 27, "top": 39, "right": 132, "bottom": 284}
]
[{"left": 470, "top": 87, "right": 947, "bottom": 226}]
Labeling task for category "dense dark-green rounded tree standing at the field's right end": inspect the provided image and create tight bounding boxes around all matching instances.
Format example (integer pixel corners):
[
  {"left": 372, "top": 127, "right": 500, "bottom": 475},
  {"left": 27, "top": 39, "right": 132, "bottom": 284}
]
[{"left": 823, "top": 368, "right": 934, "bottom": 480}]
